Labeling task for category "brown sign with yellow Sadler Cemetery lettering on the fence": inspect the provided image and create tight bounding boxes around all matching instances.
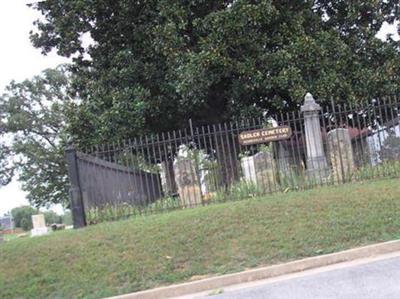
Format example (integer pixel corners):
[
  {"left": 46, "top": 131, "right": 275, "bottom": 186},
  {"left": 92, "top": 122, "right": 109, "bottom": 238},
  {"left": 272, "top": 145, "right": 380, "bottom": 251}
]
[{"left": 239, "top": 126, "right": 292, "bottom": 145}]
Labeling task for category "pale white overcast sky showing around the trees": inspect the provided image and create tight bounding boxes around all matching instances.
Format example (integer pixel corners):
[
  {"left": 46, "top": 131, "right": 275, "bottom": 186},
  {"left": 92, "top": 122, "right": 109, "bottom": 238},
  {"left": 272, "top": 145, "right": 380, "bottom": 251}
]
[{"left": 0, "top": 0, "right": 398, "bottom": 215}]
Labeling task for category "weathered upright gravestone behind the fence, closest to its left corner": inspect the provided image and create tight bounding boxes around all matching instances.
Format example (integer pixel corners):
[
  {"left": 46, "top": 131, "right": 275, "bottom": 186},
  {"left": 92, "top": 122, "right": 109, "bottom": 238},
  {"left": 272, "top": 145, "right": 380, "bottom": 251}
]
[{"left": 174, "top": 156, "right": 202, "bottom": 207}]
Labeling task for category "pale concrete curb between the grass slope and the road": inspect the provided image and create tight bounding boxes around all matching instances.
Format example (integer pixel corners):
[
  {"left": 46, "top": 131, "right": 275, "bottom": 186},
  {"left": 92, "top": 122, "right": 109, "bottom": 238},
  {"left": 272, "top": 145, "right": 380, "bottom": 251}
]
[{"left": 105, "top": 240, "right": 400, "bottom": 299}]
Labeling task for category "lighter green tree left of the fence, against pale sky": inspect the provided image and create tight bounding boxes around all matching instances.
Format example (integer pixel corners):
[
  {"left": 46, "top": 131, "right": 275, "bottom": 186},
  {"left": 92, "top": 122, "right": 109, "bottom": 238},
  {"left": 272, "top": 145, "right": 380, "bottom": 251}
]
[{"left": 0, "top": 67, "right": 75, "bottom": 207}]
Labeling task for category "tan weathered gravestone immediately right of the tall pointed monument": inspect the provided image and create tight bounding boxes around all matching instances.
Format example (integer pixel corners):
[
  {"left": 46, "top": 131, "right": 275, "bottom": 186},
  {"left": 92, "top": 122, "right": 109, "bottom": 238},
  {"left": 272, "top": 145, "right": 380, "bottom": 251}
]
[{"left": 327, "top": 128, "right": 354, "bottom": 183}]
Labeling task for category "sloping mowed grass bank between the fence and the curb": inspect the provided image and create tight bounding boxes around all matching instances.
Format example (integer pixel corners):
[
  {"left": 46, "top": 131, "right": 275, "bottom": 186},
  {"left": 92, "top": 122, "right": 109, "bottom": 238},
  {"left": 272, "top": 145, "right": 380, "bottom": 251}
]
[{"left": 0, "top": 179, "right": 400, "bottom": 298}]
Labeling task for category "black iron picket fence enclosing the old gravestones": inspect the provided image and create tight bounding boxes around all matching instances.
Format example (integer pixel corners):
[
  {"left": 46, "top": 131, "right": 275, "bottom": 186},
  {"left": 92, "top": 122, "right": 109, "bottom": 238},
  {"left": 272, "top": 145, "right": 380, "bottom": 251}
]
[{"left": 67, "top": 97, "right": 400, "bottom": 227}]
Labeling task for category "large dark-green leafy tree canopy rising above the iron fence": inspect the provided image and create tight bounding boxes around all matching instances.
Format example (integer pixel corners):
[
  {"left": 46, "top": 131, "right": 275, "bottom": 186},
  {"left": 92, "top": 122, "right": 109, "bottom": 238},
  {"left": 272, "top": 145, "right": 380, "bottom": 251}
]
[{"left": 31, "top": 0, "right": 400, "bottom": 142}]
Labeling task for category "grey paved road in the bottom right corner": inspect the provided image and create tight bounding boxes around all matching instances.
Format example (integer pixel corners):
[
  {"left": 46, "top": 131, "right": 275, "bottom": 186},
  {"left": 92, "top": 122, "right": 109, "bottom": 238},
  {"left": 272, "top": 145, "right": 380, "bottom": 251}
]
[{"left": 192, "top": 256, "right": 400, "bottom": 299}]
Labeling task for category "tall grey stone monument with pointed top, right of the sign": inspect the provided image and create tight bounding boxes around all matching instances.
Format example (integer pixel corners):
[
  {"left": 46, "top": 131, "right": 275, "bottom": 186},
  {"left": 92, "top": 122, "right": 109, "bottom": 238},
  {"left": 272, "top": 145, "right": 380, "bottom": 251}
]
[{"left": 300, "top": 93, "right": 328, "bottom": 182}]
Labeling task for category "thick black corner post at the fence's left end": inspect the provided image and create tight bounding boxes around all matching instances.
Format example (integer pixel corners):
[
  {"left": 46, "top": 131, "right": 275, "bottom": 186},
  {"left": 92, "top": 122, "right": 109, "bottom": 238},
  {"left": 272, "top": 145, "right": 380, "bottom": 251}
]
[{"left": 65, "top": 144, "right": 86, "bottom": 228}]
